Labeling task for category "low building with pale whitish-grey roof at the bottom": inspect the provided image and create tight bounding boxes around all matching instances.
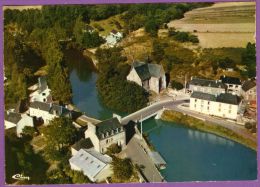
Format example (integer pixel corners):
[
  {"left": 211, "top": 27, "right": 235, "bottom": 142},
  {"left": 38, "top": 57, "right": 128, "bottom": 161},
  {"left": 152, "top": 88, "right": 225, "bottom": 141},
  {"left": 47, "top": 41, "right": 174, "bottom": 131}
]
[{"left": 69, "top": 149, "right": 113, "bottom": 182}]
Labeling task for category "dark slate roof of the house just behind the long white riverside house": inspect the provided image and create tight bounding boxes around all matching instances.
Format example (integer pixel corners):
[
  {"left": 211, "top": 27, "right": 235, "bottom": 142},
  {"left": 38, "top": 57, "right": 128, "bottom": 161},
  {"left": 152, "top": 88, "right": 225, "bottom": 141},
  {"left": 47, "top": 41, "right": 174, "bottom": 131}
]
[{"left": 189, "top": 78, "right": 226, "bottom": 88}]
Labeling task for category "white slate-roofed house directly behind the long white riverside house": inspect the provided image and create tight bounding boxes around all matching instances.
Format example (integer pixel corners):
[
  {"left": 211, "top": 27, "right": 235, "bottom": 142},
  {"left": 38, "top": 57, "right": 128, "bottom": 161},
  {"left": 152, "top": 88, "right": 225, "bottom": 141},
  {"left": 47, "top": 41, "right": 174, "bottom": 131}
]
[{"left": 188, "top": 77, "right": 226, "bottom": 94}]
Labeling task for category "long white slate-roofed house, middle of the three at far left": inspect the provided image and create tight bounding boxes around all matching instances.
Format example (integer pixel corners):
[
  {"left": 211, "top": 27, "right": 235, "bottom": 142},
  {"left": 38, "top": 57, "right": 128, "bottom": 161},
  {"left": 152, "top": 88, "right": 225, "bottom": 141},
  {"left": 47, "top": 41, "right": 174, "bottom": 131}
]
[{"left": 29, "top": 101, "right": 72, "bottom": 125}]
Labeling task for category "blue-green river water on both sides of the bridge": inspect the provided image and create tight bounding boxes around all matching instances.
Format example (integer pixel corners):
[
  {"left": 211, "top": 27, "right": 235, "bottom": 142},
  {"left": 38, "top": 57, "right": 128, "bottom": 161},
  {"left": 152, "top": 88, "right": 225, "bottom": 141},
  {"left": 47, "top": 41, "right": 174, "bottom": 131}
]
[{"left": 66, "top": 51, "right": 257, "bottom": 182}]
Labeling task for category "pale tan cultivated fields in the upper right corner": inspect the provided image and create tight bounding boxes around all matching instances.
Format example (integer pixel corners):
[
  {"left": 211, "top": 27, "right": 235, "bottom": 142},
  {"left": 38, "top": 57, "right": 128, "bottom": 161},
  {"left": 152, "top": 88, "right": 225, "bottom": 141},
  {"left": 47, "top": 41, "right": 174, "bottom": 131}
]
[{"left": 168, "top": 2, "right": 255, "bottom": 48}]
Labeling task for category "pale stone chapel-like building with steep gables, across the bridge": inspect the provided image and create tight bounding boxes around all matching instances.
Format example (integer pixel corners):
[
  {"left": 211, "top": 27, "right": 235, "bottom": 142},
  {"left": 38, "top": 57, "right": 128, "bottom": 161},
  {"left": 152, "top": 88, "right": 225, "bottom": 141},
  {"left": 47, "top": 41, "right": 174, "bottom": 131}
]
[{"left": 126, "top": 62, "right": 166, "bottom": 93}]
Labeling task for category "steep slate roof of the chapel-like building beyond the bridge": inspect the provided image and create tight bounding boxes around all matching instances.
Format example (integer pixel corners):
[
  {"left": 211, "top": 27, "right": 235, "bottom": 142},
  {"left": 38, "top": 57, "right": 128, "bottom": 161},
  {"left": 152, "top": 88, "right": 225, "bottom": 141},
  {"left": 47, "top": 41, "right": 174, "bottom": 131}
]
[{"left": 133, "top": 61, "right": 162, "bottom": 81}]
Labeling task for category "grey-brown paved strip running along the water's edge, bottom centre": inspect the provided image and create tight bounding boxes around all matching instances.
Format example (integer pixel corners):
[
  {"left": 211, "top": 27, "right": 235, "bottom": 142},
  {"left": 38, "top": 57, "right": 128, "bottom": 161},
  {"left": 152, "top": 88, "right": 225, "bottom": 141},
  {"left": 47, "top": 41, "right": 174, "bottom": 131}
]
[{"left": 125, "top": 136, "right": 163, "bottom": 182}]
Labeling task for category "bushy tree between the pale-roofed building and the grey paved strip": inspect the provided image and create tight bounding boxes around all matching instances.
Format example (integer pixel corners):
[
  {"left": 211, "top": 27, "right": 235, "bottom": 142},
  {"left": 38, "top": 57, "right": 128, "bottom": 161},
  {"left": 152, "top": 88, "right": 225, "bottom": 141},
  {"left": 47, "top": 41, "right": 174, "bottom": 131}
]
[{"left": 111, "top": 156, "right": 133, "bottom": 181}]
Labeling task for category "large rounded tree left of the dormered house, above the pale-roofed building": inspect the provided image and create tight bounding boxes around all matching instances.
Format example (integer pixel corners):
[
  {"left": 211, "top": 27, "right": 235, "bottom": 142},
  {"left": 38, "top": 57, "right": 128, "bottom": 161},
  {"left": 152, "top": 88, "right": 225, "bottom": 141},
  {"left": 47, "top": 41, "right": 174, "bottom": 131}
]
[{"left": 43, "top": 117, "right": 77, "bottom": 156}]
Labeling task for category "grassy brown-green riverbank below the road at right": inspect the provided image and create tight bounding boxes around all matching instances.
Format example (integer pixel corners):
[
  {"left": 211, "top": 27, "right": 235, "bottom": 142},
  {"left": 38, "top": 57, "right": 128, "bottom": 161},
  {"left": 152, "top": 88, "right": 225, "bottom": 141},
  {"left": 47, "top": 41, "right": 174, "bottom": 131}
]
[{"left": 161, "top": 110, "right": 257, "bottom": 151}]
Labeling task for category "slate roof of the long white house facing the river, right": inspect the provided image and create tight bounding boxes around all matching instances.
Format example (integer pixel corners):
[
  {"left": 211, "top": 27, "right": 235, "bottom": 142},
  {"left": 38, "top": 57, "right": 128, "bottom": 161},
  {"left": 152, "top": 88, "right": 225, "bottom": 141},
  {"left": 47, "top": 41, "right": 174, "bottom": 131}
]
[{"left": 191, "top": 92, "right": 241, "bottom": 105}]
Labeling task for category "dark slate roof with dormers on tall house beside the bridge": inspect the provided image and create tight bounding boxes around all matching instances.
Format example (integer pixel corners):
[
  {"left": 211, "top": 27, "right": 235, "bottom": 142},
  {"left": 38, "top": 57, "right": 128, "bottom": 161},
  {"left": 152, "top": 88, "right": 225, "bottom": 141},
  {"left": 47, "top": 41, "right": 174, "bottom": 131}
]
[{"left": 95, "top": 117, "right": 122, "bottom": 139}]
